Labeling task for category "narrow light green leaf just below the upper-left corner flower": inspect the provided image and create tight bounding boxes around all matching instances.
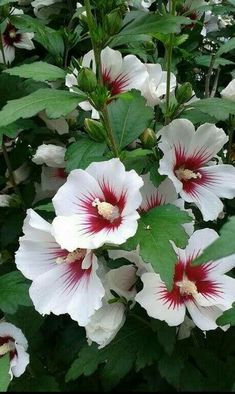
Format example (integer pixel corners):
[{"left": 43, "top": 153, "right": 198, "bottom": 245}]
[{"left": 5, "top": 62, "right": 66, "bottom": 82}]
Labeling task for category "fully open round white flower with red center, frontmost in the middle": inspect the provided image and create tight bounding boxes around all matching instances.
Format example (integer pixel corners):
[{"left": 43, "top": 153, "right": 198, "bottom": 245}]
[{"left": 53, "top": 159, "right": 143, "bottom": 251}]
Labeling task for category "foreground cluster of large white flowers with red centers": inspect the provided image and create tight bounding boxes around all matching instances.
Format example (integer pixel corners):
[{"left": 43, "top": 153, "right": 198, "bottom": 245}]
[{"left": 16, "top": 113, "right": 235, "bottom": 347}]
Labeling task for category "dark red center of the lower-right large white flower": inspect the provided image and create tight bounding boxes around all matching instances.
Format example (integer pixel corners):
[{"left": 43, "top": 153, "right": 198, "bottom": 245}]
[{"left": 160, "top": 260, "right": 221, "bottom": 308}]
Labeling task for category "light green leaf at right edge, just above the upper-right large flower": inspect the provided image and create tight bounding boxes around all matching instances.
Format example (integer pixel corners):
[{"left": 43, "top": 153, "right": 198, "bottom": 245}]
[{"left": 186, "top": 97, "right": 235, "bottom": 120}]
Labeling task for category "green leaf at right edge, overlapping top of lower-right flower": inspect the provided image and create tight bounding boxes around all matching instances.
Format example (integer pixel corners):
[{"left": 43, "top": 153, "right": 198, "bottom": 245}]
[{"left": 193, "top": 216, "right": 235, "bottom": 265}]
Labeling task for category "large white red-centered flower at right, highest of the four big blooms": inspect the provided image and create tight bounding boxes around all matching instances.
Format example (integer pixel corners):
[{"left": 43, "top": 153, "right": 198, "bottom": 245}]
[{"left": 159, "top": 119, "right": 235, "bottom": 221}]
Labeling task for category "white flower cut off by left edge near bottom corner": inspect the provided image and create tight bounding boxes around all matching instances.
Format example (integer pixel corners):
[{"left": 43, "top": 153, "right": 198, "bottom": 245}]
[{"left": 0, "top": 322, "right": 29, "bottom": 379}]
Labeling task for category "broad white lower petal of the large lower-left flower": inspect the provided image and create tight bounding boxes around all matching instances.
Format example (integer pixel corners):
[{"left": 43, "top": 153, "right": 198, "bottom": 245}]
[{"left": 30, "top": 255, "right": 104, "bottom": 325}]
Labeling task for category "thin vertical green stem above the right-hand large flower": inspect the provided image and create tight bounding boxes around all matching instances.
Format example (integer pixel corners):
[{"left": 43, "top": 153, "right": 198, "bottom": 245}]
[{"left": 165, "top": 0, "right": 175, "bottom": 124}]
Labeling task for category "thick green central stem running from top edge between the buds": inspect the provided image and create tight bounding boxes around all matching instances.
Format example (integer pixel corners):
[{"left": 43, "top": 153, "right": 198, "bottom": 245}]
[{"left": 84, "top": 0, "right": 119, "bottom": 157}]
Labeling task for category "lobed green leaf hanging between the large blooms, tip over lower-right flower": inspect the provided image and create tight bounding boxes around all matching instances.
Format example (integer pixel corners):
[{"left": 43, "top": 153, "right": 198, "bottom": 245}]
[{"left": 122, "top": 205, "right": 191, "bottom": 289}]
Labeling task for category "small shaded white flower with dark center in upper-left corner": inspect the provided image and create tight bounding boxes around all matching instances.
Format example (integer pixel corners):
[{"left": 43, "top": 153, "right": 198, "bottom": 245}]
[{"left": 0, "top": 8, "right": 34, "bottom": 64}]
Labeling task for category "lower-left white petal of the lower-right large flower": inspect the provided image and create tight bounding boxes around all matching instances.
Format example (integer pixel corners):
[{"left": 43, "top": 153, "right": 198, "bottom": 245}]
[{"left": 135, "top": 273, "right": 185, "bottom": 326}]
